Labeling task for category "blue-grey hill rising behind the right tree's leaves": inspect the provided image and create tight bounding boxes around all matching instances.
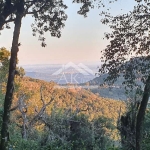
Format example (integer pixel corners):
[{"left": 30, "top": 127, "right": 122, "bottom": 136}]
[{"left": 82, "top": 57, "right": 150, "bottom": 100}]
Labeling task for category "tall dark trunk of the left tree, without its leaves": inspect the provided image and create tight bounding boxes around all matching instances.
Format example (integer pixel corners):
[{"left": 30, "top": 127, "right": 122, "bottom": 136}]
[{"left": 0, "top": 0, "right": 24, "bottom": 150}]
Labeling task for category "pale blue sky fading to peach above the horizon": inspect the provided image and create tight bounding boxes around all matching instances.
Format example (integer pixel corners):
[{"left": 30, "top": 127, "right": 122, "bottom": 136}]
[{"left": 0, "top": 0, "right": 135, "bottom": 65}]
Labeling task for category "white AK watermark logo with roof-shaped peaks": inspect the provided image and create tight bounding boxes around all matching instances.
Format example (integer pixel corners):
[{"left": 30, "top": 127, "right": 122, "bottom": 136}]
[{"left": 52, "top": 62, "right": 95, "bottom": 84}]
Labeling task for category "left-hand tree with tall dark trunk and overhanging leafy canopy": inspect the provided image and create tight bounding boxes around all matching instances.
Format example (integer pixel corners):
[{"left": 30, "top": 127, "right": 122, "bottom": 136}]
[{"left": 0, "top": 0, "right": 67, "bottom": 150}]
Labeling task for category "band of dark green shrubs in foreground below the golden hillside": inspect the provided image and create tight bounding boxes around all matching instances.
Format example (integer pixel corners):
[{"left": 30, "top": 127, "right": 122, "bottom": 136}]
[{"left": 9, "top": 102, "right": 117, "bottom": 150}]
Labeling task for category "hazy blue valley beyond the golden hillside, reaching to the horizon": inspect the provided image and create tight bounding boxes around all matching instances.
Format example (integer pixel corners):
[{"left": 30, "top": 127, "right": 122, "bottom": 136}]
[{"left": 23, "top": 63, "right": 127, "bottom": 100}]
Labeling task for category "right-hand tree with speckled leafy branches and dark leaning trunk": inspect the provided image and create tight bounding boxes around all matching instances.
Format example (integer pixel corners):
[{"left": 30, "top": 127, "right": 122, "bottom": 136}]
[{"left": 100, "top": 1, "right": 150, "bottom": 150}]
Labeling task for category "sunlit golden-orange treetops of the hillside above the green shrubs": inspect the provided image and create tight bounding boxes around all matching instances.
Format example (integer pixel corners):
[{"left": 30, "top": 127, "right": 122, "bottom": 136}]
[{"left": 12, "top": 77, "right": 124, "bottom": 120}]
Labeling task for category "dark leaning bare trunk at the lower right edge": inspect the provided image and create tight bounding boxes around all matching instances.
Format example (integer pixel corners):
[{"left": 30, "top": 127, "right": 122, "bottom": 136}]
[{"left": 136, "top": 76, "right": 150, "bottom": 150}]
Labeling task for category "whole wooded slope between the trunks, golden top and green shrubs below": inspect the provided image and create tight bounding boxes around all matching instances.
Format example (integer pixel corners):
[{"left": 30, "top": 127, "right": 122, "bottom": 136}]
[{"left": 0, "top": 77, "right": 126, "bottom": 150}]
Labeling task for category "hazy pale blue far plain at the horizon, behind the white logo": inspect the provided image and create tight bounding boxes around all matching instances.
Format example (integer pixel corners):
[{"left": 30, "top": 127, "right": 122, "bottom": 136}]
[{"left": 24, "top": 62, "right": 97, "bottom": 84}]
